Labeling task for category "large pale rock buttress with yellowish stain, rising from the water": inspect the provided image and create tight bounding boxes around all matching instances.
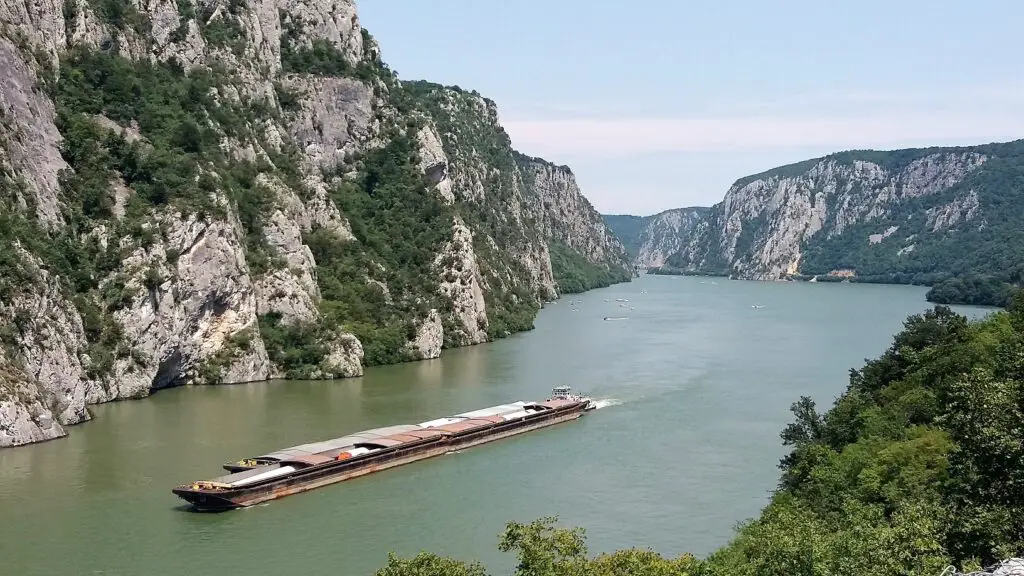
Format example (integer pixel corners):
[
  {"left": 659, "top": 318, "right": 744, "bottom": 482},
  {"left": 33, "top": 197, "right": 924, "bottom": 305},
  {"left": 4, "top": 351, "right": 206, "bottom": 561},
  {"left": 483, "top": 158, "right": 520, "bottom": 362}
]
[{"left": 99, "top": 214, "right": 270, "bottom": 402}]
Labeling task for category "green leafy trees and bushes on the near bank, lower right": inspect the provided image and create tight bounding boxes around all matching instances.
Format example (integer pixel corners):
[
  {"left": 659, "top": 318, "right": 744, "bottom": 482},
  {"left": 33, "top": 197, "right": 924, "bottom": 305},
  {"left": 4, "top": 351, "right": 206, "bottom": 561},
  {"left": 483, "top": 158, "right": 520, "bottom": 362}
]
[{"left": 378, "top": 294, "right": 1024, "bottom": 576}]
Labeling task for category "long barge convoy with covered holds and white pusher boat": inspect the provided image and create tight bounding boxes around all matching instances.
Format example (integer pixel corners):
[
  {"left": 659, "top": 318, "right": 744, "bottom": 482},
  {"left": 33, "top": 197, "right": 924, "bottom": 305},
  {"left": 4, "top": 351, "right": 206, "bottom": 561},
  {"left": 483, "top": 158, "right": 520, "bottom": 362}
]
[{"left": 172, "top": 386, "right": 595, "bottom": 510}]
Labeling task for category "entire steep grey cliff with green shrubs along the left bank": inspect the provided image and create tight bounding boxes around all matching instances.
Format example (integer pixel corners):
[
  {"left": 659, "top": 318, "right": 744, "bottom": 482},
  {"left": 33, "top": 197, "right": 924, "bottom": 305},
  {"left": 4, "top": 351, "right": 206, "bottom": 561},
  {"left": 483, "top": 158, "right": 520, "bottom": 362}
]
[{"left": 0, "top": 0, "right": 629, "bottom": 446}]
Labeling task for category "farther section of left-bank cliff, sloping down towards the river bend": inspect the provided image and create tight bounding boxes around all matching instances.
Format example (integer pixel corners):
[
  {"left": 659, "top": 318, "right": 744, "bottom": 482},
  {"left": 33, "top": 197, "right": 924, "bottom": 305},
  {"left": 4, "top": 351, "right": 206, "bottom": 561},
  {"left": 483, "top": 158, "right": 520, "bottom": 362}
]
[{"left": 406, "top": 81, "right": 633, "bottom": 301}]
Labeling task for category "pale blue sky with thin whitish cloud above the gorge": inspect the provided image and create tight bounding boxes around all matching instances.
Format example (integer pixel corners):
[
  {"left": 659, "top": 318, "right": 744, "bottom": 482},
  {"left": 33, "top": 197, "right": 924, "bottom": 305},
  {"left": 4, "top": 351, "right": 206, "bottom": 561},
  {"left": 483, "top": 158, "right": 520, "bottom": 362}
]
[{"left": 357, "top": 0, "right": 1024, "bottom": 215}]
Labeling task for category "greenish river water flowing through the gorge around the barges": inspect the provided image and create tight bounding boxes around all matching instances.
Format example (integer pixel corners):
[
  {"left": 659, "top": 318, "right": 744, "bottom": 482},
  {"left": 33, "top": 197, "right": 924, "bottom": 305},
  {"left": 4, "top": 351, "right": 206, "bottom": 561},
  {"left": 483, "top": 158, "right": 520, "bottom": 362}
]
[{"left": 0, "top": 276, "right": 987, "bottom": 576}]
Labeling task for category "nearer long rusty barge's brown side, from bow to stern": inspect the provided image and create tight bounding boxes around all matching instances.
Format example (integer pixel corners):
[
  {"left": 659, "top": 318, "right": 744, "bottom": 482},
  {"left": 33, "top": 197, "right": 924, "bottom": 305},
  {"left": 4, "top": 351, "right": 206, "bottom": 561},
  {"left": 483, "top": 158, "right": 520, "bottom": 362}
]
[{"left": 173, "top": 403, "right": 590, "bottom": 511}]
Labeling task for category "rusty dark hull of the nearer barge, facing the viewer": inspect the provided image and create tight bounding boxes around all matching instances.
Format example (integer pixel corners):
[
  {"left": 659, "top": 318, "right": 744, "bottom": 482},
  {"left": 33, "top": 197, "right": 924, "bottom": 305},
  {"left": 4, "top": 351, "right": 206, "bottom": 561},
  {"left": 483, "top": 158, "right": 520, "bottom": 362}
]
[{"left": 173, "top": 407, "right": 584, "bottom": 511}]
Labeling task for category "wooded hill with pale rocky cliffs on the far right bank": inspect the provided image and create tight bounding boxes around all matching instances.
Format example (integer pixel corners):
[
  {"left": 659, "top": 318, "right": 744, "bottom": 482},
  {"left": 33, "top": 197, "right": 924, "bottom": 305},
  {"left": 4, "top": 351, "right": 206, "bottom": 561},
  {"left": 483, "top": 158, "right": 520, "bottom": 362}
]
[{"left": 667, "top": 142, "right": 1024, "bottom": 283}]
